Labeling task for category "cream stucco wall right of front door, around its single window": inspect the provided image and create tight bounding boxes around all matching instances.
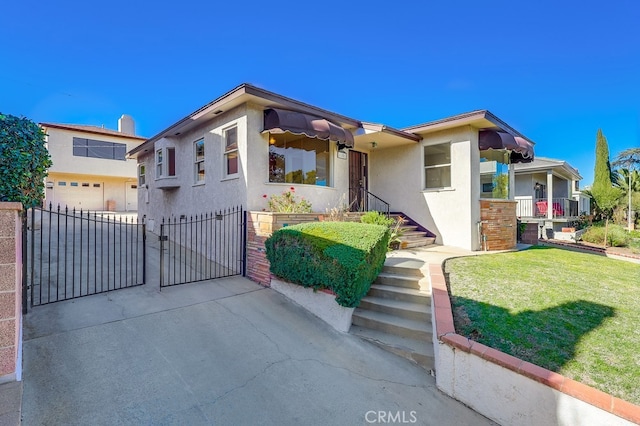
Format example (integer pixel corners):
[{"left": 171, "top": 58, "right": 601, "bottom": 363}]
[{"left": 370, "top": 126, "right": 480, "bottom": 250}]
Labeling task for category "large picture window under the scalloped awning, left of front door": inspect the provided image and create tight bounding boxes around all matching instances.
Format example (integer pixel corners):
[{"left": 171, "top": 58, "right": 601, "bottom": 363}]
[{"left": 269, "top": 133, "right": 331, "bottom": 186}]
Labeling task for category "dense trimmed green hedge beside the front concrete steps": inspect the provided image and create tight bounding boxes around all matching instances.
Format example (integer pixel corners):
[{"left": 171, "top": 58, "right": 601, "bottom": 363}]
[{"left": 265, "top": 222, "right": 390, "bottom": 308}]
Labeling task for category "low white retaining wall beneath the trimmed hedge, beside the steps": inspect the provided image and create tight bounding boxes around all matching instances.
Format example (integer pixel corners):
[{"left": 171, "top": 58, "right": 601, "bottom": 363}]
[{"left": 271, "top": 277, "right": 355, "bottom": 333}]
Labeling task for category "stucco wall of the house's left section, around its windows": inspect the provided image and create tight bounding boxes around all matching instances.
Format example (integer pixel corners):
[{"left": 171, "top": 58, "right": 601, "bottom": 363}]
[{"left": 138, "top": 104, "right": 356, "bottom": 226}]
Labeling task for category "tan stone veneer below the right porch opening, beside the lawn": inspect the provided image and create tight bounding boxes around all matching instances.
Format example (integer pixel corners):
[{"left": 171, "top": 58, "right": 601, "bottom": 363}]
[{"left": 480, "top": 200, "right": 517, "bottom": 250}]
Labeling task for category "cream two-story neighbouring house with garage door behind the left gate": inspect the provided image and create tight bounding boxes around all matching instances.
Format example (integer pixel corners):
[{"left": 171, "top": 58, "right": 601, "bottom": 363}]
[{"left": 40, "top": 115, "right": 145, "bottom": 211}]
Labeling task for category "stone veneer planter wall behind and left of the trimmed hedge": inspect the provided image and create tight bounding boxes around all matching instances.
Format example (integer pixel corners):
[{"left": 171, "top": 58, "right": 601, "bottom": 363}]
[{"left": 247, "top": 211, "right": 361, "bottom": 287}]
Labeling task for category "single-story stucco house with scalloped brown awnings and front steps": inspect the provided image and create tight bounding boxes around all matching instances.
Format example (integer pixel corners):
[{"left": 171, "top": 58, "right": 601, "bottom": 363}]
[{"left": 129, "top": 84, "right": 534, "bottom": 250}]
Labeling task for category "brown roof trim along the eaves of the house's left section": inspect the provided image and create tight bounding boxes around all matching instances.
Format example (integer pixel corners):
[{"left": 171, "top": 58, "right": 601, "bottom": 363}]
[{"left": 128, "top": 83, "right": 361, "bottom": 155}]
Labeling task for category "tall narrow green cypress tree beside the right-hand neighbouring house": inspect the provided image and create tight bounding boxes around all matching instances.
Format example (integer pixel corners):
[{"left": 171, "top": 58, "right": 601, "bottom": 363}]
[{"left": 591, "top": 129, "right": 622, "bottom": 247}]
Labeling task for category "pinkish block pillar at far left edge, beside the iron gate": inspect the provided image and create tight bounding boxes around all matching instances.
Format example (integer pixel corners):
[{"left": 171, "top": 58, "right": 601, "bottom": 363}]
[{"left": 0, "top": 203, "right": 22, "bottom": 383}]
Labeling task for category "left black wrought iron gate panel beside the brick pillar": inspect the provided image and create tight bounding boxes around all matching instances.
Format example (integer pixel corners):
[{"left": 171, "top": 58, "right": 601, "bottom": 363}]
[{"left": 24, "top": 205, "right": 146, "bottom": 306}]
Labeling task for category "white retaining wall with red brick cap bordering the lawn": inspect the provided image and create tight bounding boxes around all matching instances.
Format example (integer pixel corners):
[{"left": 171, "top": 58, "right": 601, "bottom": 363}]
[{"left": 429, "top": 265, "right": 640, "bottom": 426}]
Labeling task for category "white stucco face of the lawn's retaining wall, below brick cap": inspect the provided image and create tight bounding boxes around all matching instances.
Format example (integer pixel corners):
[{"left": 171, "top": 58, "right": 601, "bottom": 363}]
[{"left": 436, "top": 343, "right": 633, "bottom": 426}]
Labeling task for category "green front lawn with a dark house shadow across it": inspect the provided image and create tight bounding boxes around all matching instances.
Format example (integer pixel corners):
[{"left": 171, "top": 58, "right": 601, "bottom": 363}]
[{"left": 445, "top": 247, "right": 640, "bottom": 405}]
